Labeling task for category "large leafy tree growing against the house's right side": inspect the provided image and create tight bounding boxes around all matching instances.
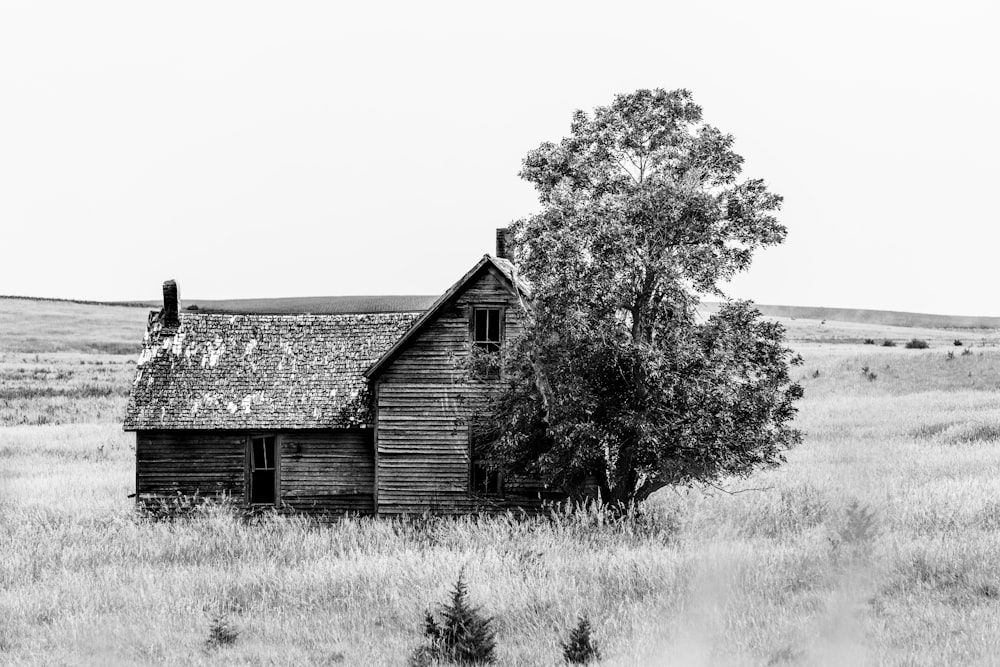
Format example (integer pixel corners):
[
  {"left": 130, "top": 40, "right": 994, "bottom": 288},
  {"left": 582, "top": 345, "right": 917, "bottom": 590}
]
[{"left": 477, "top": 89, "right": 801, "bottom": 504}]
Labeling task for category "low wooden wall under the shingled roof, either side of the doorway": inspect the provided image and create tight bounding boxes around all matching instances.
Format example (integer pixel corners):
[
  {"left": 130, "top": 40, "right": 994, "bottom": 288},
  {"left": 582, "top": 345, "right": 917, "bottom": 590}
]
[{"left": 136, "top": 429, "right": 375, "bottom": 513}]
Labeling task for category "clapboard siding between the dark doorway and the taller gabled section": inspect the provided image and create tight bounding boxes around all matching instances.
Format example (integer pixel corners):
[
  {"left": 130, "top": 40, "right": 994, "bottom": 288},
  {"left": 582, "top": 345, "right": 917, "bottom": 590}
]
[{"left": 278, "top": 429, "right": 375, "bottom": 514}]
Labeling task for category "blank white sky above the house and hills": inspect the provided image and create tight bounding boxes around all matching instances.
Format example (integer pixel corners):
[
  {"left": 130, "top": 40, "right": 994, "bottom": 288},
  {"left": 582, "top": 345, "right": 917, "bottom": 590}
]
[{"left": 0, "top": 0, "right": 1000, "bottom": 316}]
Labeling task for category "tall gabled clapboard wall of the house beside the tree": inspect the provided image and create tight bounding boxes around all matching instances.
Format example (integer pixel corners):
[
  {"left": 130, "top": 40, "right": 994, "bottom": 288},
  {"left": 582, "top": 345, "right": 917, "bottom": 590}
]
[{"left": 376, "top": 269, "right": 540, "bottom": 514}]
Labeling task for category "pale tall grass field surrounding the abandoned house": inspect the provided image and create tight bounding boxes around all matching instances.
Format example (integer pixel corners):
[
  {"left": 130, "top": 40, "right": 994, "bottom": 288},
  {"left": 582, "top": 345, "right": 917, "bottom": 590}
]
[{"left": 0, "top": 304, "right": 1000, "bottom": 666}]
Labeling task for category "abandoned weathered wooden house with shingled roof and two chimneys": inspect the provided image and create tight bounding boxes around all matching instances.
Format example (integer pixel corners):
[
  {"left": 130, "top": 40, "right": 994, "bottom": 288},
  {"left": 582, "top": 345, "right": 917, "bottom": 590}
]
[{"left": 125, "top": 230, "right": 541, "bottom": 514}]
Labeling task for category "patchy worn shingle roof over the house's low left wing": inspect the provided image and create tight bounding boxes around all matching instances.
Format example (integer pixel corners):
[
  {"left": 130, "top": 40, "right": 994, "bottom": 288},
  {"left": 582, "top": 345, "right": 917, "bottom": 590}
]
[{"left": 125, "top": 312, "right": 420, "bottom": 431}]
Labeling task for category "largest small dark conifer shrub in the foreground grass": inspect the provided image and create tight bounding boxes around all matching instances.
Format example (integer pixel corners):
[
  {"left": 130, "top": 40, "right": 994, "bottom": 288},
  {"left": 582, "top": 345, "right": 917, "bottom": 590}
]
[{"left": 410, "top": 568, "right": 496, "bottom": 666}]
